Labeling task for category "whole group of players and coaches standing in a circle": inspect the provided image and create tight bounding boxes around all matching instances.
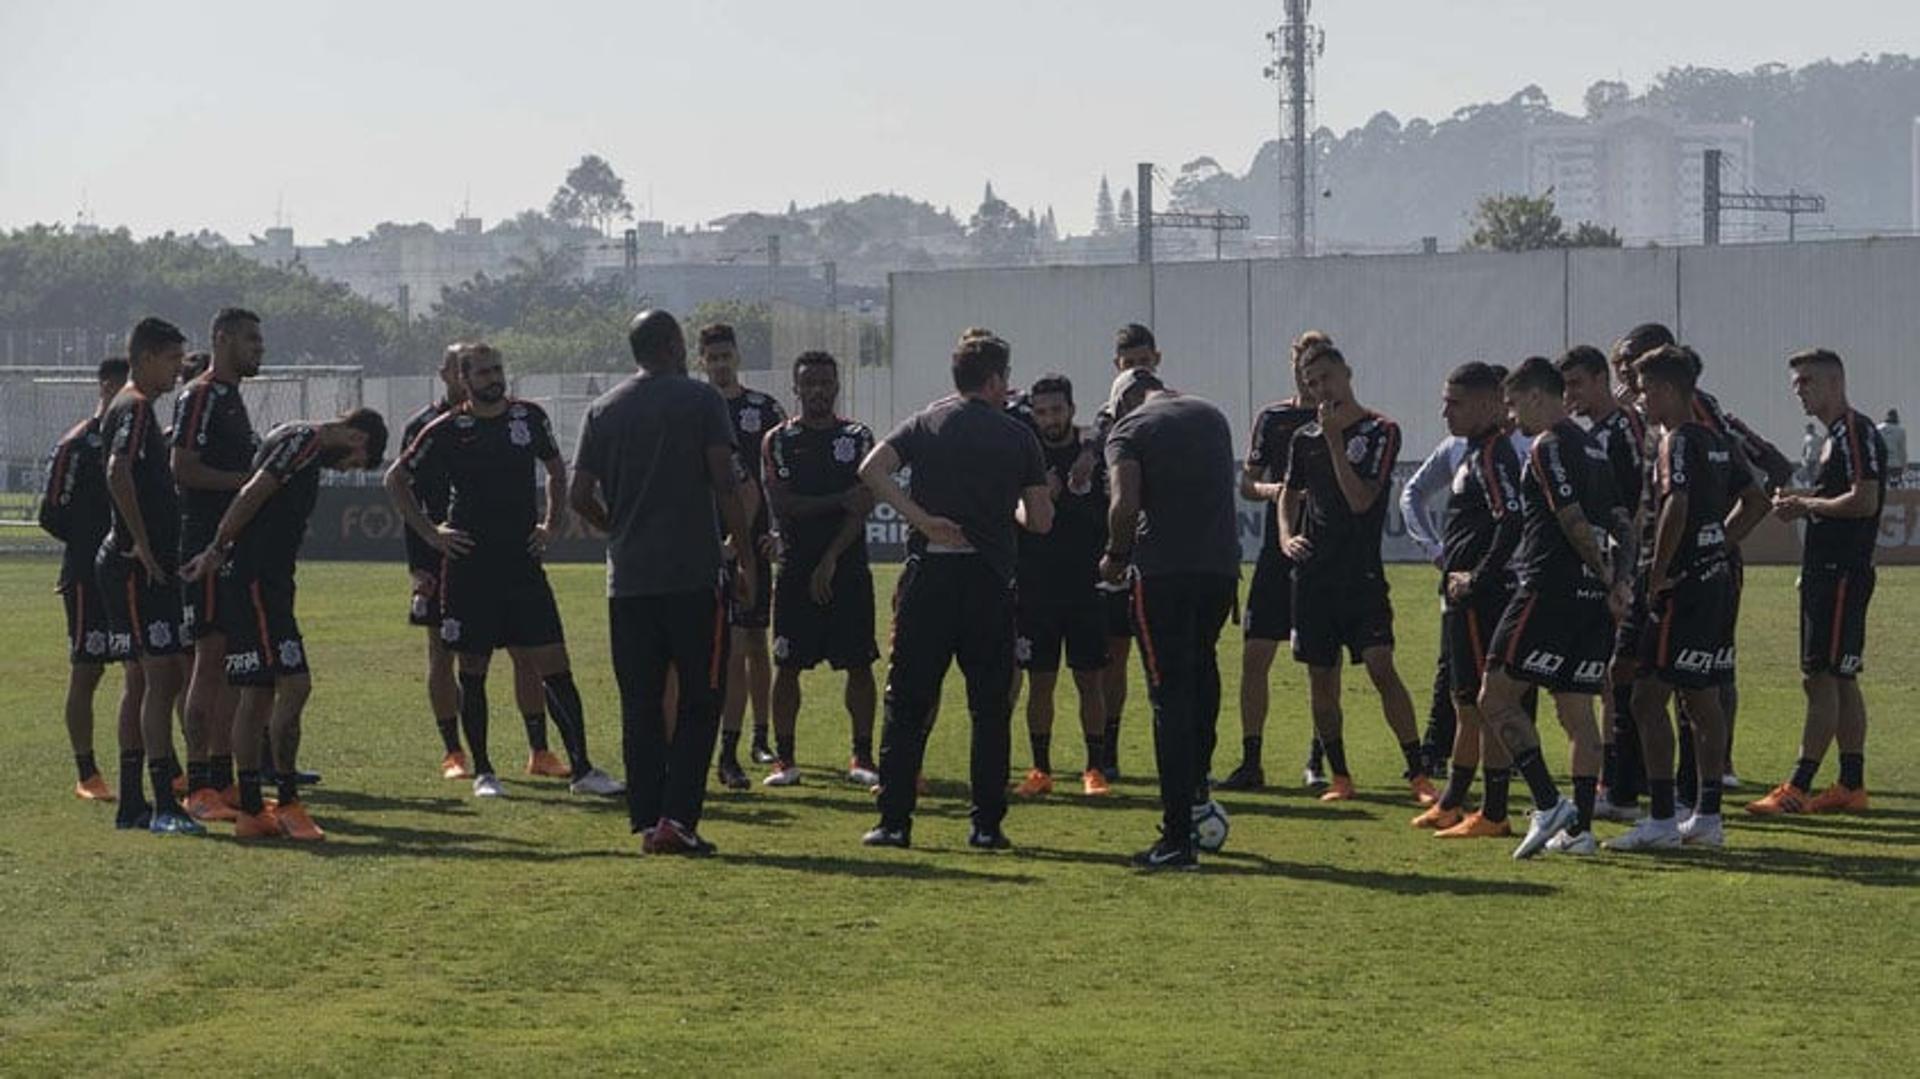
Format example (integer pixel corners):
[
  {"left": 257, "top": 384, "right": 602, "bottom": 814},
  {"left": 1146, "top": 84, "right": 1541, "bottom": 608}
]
[{"left": 42, "top": 309, "right": 1885, "bottom": 870}]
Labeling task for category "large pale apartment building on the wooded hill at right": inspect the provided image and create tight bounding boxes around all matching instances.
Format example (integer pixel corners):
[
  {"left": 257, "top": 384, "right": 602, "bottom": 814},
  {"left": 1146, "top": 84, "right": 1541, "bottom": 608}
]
[{"left": 1526, "top": 108, "right": 1755, "bottom": 244}]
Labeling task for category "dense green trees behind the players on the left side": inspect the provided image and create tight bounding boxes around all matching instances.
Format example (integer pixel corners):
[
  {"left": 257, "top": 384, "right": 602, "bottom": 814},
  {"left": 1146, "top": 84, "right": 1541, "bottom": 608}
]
[{"left": 0, "top": 227, "right": 768, "bottom": 374}]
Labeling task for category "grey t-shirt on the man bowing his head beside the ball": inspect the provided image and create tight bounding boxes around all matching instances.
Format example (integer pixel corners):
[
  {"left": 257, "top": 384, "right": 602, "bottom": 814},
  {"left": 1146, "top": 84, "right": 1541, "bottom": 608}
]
[{"left": 1106, "top": 394, "right": 1240, "bottom": 576}]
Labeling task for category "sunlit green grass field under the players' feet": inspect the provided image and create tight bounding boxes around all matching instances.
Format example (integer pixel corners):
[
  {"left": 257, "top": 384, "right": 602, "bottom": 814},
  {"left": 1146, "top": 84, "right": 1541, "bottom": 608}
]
[{"left": 0, "top": 559, "right": 1920, "bottom": 1077}]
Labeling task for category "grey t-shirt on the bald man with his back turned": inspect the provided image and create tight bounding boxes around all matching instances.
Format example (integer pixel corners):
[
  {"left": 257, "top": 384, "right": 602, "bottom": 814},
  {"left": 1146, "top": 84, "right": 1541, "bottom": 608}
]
[{"left": 574, "top": 372, "right": 733, "bottom": 597}]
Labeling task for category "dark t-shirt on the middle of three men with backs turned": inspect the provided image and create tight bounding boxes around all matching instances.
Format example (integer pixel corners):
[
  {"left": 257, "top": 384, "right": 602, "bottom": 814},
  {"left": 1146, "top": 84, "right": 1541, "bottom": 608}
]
[{"left": 887, "top": 397, "right": 1046, "bottom": 580}]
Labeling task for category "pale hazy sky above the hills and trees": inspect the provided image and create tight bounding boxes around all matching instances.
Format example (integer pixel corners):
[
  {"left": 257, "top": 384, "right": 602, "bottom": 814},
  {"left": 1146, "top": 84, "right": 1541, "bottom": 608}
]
[{"left": 0, "top": 0, "right": 1920, "bottom": 242}]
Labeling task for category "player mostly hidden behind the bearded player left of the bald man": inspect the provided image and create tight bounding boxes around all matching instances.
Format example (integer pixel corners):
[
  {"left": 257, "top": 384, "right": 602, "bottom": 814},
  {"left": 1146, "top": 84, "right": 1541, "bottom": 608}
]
[{"left": 399, "top": 342, "right": 572, "bottom": 779}]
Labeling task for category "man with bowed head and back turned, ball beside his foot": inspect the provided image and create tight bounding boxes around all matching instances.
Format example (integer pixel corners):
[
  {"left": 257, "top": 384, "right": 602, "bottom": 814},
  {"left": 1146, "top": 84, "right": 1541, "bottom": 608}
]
[{"left": 1100, "top": 369, "right": 1240, "bottom": 870}]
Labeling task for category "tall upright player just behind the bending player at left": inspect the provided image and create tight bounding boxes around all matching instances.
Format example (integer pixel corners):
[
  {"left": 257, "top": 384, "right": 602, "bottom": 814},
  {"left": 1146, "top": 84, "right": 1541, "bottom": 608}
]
[{"left": 169, "top": 307, "right": 267, "bottom": 820}]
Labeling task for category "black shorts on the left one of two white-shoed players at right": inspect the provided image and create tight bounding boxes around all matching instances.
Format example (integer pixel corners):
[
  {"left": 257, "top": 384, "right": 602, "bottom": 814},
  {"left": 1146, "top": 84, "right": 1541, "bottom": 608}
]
[{"left": 1486, "top": 587, "right": 1613, "bottom": 693}]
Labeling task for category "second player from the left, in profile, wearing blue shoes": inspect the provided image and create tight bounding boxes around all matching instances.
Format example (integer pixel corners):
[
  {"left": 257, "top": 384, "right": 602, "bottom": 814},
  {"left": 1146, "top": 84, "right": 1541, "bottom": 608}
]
[{"left": 94, "top": 319, "right": 192, "bottom": 835}]
